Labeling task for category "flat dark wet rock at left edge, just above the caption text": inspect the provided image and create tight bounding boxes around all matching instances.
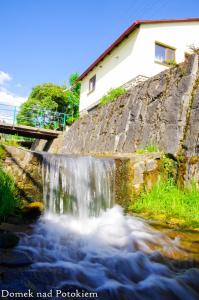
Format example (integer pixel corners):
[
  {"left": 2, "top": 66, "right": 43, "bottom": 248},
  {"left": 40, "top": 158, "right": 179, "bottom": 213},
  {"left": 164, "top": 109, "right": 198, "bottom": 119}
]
[{"left": 0, "top": 250, "right": 33, "bottom": 267}]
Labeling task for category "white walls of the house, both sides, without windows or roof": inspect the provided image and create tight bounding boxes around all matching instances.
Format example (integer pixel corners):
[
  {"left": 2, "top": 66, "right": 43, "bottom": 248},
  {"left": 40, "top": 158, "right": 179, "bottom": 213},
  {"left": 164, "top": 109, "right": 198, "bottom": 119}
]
[{"left": 80, "top": 22, "right": 199, "bottom": 111}]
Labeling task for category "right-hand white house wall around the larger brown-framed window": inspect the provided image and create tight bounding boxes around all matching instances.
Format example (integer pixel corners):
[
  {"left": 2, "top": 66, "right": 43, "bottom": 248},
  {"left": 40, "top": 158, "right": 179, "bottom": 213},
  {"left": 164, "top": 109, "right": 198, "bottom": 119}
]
[{"left": 132, "top": 22, "right": 199, "bottom": 77}]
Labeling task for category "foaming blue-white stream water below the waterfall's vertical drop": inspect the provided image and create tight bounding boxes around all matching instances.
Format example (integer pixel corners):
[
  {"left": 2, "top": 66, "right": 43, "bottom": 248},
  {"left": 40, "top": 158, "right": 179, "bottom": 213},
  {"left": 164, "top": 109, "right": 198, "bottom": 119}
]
[{"left": 0, "top": 206, "right": 199, "bottom": 300}]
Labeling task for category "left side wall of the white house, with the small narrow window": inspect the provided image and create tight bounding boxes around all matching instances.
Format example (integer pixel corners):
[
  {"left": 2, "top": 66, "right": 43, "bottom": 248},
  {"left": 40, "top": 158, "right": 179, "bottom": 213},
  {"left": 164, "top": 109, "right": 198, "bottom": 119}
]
[{"left": 80, "top": 31, "right": 138, "bottom": 111}]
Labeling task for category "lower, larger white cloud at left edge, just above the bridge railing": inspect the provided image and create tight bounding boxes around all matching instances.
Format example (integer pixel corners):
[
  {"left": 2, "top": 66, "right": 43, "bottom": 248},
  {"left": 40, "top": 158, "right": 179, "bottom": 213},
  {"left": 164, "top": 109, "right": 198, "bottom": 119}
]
[{"left": 0, "top": 88, "right": 27, "bottom": 106}]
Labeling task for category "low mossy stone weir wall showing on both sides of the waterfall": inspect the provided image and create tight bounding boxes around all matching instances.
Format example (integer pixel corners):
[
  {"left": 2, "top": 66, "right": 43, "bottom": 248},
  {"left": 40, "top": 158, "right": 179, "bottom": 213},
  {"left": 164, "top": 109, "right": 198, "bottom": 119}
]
[{"left": 1, "top": 146, "right": 160, "bottom": 208}]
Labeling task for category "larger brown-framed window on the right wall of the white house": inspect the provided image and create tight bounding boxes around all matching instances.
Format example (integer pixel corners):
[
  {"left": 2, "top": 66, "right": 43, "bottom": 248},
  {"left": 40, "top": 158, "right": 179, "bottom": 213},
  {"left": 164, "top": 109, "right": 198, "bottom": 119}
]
[{"left": 155, "top": 43, "right": 175, "bottom": 65}]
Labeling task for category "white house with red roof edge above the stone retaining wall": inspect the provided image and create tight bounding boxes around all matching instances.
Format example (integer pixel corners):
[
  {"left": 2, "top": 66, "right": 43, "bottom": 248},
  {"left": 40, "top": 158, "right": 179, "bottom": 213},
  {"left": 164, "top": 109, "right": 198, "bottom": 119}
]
[{"left": 78, "top": 18, "right": 199, "bottom": 113}]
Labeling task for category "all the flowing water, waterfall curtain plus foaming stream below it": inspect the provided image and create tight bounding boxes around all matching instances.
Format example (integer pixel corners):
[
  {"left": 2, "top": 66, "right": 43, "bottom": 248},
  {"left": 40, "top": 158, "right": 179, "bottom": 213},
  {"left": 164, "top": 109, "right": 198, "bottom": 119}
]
[{"left": 5, "top": 155, "right": 199, "bottom": 300}]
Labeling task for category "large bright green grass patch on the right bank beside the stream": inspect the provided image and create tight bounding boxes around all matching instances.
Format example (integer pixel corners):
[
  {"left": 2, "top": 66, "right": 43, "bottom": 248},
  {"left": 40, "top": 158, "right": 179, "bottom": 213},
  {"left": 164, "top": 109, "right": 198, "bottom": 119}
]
[{"left": 129, "top": 178, "right": 199, "bottom": 228}]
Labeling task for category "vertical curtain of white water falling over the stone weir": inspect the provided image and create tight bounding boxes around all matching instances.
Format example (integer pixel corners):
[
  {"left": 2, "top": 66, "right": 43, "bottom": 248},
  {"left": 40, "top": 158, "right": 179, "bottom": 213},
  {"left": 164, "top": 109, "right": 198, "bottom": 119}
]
[{"left": 42, "top": 154, "right": 115, "bottom": 218}]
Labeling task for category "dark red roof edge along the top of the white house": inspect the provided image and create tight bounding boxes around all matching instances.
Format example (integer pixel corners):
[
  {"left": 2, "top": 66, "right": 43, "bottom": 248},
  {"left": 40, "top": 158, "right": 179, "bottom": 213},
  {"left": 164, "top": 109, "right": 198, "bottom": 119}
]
[{"left": 78, "top": 18, "right": 199, "bottom": 81}]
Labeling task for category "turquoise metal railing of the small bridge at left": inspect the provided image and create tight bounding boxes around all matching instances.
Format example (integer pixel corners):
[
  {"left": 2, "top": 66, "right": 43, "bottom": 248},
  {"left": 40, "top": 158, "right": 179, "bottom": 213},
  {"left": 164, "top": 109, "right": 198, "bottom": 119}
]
[{"left": 0, "top": 103, "right": 69, "bottom": 131}]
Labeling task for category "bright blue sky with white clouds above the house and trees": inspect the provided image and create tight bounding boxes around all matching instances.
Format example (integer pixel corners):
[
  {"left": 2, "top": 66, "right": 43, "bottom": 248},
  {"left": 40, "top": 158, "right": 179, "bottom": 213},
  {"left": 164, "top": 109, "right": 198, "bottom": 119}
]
[{"left": 0, "top": 0, "right": 199, "bottom": 105}]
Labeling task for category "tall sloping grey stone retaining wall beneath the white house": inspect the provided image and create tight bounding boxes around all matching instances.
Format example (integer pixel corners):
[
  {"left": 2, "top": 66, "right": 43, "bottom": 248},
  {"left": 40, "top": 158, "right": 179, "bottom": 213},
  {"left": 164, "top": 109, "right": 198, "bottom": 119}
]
[{"left": 59, "top": 56, "right": 199, "bottom": 162}]
